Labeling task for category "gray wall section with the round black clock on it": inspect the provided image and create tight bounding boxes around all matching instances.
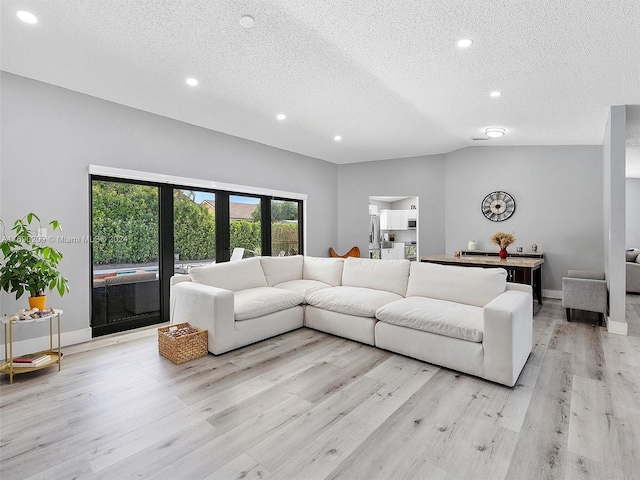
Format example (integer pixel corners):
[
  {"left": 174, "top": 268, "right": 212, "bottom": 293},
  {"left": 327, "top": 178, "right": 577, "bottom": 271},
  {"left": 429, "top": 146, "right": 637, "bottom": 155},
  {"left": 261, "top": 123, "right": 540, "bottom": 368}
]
[{"left": 446, "top": 146, "right": 604, "bottom": 291}]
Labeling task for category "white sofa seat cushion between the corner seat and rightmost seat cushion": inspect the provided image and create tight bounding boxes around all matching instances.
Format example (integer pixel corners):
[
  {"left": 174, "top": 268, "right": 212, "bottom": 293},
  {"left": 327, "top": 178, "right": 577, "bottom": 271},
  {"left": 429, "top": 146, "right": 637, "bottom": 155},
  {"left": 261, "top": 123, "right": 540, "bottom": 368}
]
[{"left": 307, "top": 287, "right": 402, "bottom": 317}]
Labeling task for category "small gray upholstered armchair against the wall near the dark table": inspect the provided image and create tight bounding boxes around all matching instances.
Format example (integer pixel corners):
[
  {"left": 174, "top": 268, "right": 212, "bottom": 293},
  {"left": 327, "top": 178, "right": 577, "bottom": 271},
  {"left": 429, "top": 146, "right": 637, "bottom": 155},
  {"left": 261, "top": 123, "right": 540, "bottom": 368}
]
[{"left": 562, "top": 270, "right": 608, "bottom": 325}]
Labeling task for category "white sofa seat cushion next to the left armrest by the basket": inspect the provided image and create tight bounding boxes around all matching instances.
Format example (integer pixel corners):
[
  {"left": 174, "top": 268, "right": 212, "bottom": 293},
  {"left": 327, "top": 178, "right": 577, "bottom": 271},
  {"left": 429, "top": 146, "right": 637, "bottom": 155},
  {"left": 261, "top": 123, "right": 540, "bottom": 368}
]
[{"left": 233, "top": 287, "right": 304, "bottom": 322}]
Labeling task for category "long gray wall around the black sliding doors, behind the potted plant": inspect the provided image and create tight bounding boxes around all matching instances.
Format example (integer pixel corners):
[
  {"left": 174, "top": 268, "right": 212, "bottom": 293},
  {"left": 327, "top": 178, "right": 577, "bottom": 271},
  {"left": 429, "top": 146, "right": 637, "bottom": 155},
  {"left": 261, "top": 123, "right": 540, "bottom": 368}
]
[{"left": 0, "top": 72, "right": 340, "bottom": 340}]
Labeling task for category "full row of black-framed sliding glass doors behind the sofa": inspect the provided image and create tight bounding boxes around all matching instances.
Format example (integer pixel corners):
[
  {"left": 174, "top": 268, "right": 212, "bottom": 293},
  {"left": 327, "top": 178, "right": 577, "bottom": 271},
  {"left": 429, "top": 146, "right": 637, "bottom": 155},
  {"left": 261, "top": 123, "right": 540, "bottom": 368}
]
[{"left": 91, "top": 176, "right": 303, "bottom": 337}]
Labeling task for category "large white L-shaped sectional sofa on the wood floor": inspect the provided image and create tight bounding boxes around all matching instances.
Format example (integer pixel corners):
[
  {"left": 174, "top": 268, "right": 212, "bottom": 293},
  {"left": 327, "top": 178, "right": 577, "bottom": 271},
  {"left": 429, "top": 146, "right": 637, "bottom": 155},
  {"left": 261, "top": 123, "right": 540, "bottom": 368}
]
[{"left": 171, "top": 256, "right": 533, "bottom": 386}]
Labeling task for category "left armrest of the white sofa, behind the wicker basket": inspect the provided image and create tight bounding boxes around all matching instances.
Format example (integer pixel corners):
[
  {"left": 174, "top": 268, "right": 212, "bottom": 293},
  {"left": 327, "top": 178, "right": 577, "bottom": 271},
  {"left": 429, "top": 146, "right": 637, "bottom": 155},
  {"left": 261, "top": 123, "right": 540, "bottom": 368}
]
[{"left": 170, "top": 282, "right": 235, "bottom": 355}]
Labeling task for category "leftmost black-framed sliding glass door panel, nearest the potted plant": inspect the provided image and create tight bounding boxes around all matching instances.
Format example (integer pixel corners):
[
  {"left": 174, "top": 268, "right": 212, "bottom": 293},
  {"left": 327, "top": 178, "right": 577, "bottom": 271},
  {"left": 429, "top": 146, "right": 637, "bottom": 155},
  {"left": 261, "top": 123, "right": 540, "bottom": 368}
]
[{"left": 91, "top": 180, "right": 160, "bottom": 336}]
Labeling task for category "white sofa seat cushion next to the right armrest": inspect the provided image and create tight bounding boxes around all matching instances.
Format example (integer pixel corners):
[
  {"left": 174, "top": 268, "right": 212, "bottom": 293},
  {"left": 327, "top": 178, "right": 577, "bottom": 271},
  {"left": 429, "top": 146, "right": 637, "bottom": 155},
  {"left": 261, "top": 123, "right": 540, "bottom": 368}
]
[{"left": 376, "top": 297, "right": 483, "bottom": 342}]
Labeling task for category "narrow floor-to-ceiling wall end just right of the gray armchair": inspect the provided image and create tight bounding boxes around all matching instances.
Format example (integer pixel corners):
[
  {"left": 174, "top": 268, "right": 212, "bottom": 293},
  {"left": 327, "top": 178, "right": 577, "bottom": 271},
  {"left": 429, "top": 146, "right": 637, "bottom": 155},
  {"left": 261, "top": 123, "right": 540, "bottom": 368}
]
[{"left": 602, "top": 105, "right": 627, "bottom": 335}]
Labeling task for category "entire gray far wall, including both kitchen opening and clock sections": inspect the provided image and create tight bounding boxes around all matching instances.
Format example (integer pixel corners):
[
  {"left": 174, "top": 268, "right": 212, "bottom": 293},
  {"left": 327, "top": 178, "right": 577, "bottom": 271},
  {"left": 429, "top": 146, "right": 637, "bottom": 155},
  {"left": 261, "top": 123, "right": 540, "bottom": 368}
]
[{"left": 338, "top": 146, "right": 604, "bottom": 293}]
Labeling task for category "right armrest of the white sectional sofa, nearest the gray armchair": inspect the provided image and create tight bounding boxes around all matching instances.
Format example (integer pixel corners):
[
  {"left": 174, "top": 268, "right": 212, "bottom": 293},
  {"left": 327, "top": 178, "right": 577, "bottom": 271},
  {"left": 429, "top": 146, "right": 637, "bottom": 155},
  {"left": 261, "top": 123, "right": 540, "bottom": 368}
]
[{"left": 482, "top": 290, "right": 533, "bottom": 387}]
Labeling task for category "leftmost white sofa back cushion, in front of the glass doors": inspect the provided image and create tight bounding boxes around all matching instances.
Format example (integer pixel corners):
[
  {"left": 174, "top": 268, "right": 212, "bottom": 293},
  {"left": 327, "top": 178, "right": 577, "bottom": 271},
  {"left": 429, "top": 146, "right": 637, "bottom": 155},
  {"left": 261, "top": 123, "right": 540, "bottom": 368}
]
[{"left": 189, "top": 257, "right": 267, "bottom": 292}]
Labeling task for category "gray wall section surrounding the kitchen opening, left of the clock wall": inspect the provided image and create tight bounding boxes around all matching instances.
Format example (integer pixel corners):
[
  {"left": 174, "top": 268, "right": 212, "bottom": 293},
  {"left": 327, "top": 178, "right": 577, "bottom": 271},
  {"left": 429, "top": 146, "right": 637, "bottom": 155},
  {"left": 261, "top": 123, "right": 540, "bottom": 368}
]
[{"left": 337, "top": 155, "right": 445, "bottom": 255}]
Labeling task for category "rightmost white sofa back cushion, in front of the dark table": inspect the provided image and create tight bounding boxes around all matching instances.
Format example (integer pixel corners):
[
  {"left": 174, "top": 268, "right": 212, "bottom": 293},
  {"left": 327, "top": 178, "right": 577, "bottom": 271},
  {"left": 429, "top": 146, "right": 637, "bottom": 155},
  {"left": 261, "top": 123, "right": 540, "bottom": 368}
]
[{"left": 407, "top": 262, "right": 507, "bottom": 307}]
